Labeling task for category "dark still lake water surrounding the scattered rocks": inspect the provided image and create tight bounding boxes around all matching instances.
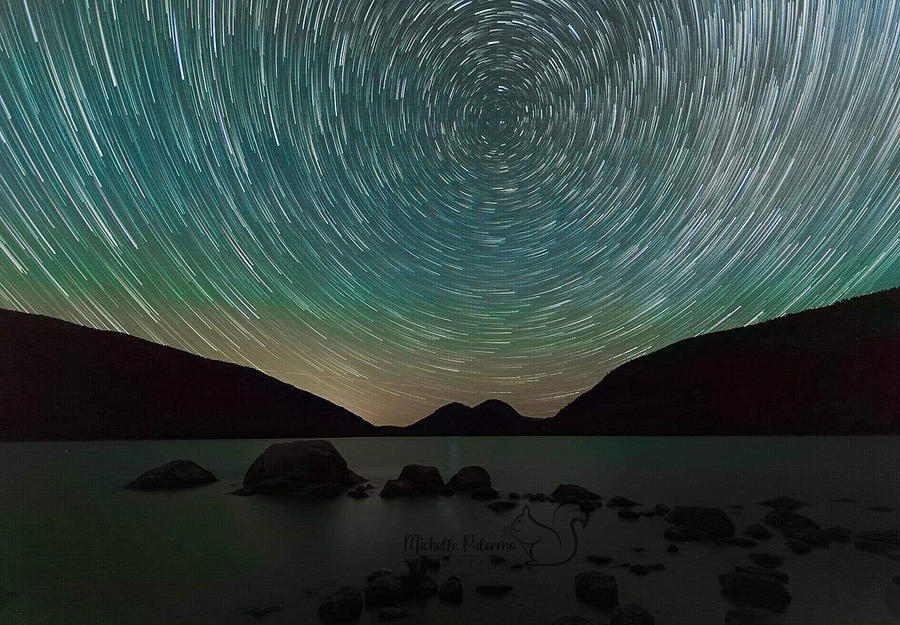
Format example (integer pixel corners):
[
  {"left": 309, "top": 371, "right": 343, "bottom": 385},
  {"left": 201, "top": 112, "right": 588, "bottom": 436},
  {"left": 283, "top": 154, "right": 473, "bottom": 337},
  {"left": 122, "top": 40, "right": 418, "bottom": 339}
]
[{"left": 0, "top": 437, "right": 900, "bottom": 625}]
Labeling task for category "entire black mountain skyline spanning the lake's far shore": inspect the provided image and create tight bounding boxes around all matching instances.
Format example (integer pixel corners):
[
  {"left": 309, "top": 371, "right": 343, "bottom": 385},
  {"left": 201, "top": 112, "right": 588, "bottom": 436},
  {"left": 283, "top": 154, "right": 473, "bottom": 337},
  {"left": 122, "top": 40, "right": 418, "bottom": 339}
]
[{"left": 0, "top": 289, "right": 900, "bottom": 440}]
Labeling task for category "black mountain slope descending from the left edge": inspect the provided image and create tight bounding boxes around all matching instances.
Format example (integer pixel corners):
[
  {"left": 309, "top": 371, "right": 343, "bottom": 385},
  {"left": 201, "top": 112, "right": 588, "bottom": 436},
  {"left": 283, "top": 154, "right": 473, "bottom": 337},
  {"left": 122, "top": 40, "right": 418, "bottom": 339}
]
[{"left": 0, "top": 310, "right": 376, "bottom": 440}]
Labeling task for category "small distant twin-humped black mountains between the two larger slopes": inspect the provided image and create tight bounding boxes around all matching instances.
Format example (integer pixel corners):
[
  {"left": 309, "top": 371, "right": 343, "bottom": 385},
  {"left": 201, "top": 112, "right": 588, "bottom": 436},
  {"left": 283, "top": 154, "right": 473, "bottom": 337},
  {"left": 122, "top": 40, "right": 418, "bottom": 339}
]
[{"left": 402, "top": 399, "right": 540, "bottom": 436}]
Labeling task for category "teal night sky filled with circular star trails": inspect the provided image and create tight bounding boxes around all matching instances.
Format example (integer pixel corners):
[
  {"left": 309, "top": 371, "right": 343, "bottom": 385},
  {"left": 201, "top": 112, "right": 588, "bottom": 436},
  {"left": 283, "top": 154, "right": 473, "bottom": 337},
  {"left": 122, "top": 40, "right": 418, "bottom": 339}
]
[{"left": 0, "top": 0, "right": 900, "bottom": 423}]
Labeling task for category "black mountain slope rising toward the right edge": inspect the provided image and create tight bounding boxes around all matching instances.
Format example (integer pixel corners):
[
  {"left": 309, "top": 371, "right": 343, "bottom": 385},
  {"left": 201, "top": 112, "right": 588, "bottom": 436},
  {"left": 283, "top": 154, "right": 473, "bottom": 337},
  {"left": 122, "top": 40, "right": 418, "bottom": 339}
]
[{"left": 540, "top": 289, "right": 900, "bottom": 435}]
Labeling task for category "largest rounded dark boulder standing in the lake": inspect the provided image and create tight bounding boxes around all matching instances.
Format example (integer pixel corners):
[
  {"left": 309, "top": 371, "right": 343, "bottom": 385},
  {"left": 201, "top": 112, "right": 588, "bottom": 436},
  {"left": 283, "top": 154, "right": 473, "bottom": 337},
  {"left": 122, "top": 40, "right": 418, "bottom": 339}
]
[{"left": 238, "top": 440, "right": 366, "bottom": 498}]
